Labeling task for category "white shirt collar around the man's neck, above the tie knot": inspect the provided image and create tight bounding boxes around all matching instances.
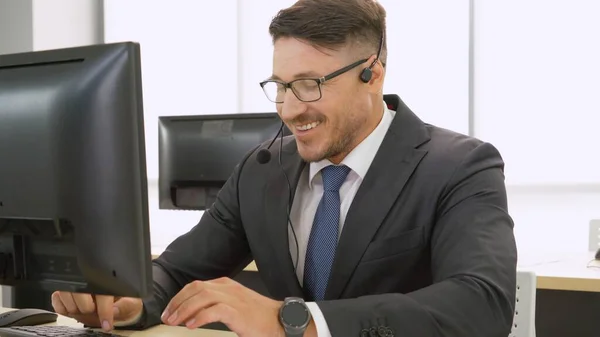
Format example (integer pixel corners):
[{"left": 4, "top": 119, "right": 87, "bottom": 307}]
[{"left": 308, "top": 102, "right": 395, "bottom": 189}]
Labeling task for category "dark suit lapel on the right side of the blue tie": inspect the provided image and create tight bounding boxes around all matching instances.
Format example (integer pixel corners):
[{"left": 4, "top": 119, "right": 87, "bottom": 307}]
[{"left": 325, "top": 95, "right": 429, "bottom": 300}]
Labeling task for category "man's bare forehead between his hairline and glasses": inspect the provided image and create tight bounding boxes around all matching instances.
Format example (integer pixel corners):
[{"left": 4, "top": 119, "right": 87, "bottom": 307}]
[{"left": 271, "top": 37, "right": 342, "bottom": 81}]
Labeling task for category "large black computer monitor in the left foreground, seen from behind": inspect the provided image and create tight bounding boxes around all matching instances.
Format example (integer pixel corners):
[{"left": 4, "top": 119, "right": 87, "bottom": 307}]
[{"left": 0, "top": 43, "right": 152, "bottom": 297}]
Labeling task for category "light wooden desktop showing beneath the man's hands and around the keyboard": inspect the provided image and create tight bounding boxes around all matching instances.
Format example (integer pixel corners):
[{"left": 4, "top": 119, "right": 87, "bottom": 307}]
[{"left": 0, "top": 307, "right": 236, "bottom": 337}]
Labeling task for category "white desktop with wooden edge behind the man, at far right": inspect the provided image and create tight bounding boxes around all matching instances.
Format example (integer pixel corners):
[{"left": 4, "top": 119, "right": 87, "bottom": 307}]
[{"left": 519, "top": 252, "right": 600, "bottom": 292}]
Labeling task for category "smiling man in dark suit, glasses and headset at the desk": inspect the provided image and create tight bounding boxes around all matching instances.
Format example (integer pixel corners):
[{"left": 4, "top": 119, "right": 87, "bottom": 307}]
[{"left": 52, "top": 0, "right": 516, "bottom": 337}]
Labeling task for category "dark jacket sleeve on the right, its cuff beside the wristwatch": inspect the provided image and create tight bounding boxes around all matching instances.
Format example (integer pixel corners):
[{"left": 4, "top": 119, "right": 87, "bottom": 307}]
[{"left": 318, "top": 143, "right": 517, "bottom": 337}]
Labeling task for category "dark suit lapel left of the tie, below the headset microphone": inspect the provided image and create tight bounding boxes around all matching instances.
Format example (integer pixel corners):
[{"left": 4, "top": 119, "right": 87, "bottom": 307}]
[{"left": 264, "top": 137, "right": 306, "bottom": 297}]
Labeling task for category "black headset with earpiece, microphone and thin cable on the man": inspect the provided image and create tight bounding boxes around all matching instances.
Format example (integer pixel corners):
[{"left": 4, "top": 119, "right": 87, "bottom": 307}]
[{"left": 256, "top": 31, "right": 385, "bottom": 273}]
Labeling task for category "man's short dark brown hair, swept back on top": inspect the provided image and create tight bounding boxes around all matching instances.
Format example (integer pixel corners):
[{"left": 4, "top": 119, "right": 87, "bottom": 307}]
[{"left": 269, "top": 0, "right": 387, "bottom": 65}]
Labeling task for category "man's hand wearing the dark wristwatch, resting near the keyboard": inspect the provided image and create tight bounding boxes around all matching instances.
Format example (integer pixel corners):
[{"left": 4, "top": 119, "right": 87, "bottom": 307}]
[{"left": 162, "top": 278, "right": 308, "bottom": 337}]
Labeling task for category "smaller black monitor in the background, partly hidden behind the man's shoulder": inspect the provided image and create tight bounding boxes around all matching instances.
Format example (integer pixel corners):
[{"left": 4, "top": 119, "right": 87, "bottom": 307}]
[{"left": 158, "top": 112, "right": 291, "bottom": 210}]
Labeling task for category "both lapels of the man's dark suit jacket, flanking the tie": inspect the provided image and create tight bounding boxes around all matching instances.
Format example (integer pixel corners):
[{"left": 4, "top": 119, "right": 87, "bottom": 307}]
[{"left": 264, "top": 95, "right": 430, "bottom": 300}]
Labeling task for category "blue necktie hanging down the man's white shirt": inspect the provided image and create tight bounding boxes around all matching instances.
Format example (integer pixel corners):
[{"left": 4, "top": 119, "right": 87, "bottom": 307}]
[{"left": 304, "top": 166, "right": 350, "bottom": 301}]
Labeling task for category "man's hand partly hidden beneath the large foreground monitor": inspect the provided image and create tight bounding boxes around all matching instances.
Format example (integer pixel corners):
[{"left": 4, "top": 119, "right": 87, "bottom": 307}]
[{"left": 52, "top": 291, "right": 143, "bottom": 331}]
